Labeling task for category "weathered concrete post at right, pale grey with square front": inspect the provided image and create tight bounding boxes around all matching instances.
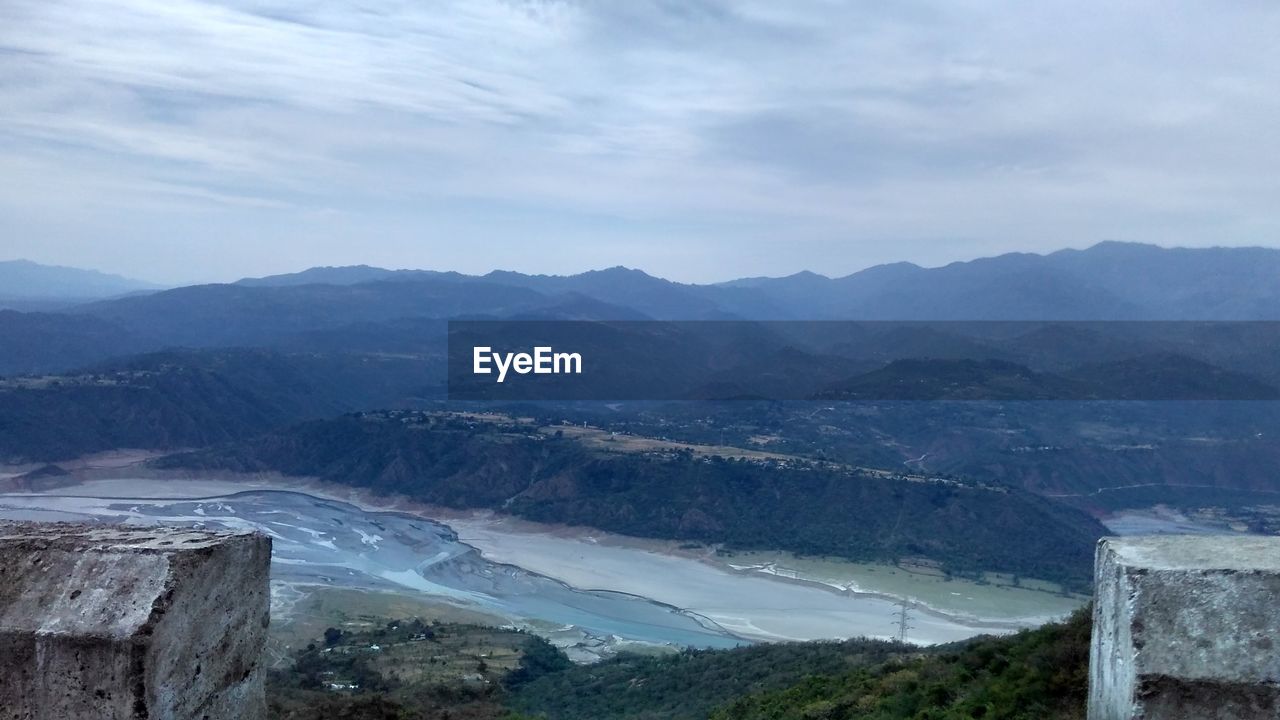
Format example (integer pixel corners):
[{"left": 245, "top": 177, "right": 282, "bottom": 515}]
[{"left": 1089, "top": 536, "right": 1280, "bottom": 720}]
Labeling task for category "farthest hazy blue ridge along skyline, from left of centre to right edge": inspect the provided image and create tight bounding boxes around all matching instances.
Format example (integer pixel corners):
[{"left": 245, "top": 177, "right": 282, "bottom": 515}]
[{"left": 222, "top": 242, "right": 1280, "bottom": 320}]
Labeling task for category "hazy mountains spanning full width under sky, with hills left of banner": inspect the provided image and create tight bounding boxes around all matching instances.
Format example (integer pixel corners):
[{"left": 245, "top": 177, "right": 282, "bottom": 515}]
[{"left": 0, "top": 242, "right": 1280, "bottom": 374}]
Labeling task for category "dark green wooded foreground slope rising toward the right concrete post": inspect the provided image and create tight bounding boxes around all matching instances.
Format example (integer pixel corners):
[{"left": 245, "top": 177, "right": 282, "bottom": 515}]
[{"left": 508, "top": 609, "right": 1091, "bottom": 720}]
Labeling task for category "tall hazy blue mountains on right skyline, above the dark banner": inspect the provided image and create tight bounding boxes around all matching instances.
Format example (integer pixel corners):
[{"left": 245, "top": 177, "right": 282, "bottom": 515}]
[{"left": 716, "top": 242, "right": 1280, "bottom": 320}]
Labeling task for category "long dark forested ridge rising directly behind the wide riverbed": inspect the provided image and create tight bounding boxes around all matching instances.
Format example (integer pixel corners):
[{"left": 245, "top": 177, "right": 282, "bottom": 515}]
[{"left": 160, "top": 411, "right": 1103, "bottom": 589}]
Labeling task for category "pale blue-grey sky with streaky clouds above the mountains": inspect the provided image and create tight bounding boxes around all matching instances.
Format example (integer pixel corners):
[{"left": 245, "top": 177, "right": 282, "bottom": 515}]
[{"left": 0, "top": 0, "right": 1280, "bottom": 283}]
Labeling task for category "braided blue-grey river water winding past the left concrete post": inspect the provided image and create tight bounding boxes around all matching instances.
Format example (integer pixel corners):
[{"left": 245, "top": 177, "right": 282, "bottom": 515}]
[{"left": 0, "top": 481, "right": 742, "bottom": 647}]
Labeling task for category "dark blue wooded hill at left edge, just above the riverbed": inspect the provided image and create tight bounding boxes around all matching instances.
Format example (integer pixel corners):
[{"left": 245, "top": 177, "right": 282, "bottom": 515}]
[{"left": 0, "top": 350, "right": 422, "bottom": 462}]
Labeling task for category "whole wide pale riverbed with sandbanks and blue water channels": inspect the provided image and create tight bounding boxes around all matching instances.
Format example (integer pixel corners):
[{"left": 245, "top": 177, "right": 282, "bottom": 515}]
[{"left": 0, "top": 478, "right": 1028, "bottom": 647}]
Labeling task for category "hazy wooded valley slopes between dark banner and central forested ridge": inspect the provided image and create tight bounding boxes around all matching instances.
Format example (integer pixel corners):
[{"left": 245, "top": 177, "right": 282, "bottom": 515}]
[{"left": 552, "top": 401, "right": 1280, "bottom": 511}]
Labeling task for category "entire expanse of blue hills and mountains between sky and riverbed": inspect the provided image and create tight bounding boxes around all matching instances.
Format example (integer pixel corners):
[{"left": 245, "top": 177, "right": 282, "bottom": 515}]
[{"left": 0, "top": 243, "right": 1280, "bottom": 585}]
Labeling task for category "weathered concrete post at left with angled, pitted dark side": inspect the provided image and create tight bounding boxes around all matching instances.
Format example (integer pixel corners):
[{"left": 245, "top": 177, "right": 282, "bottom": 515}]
[{"left": 0, "top": 523, "right": 271, "bottom": 720}]
